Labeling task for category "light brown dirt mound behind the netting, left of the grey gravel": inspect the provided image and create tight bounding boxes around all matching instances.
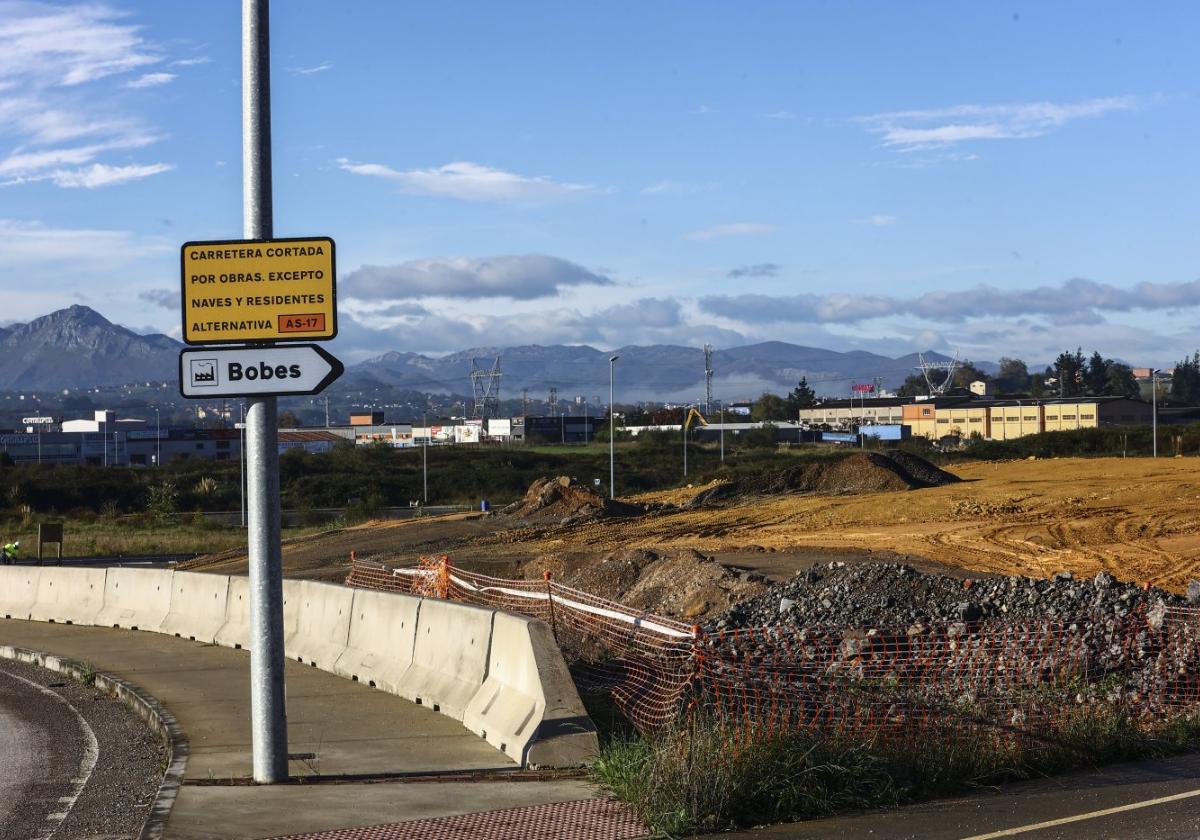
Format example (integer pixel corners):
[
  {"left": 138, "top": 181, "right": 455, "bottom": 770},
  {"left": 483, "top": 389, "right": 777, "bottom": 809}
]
[{"left": 521, "top": 548, "right": 768, "bottom": 622}]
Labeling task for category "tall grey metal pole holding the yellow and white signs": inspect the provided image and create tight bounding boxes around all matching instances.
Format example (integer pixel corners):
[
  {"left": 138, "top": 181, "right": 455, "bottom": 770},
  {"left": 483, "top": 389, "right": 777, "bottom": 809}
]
[{"left": 241, "top": 0, "right": 288, "bottom": 784}]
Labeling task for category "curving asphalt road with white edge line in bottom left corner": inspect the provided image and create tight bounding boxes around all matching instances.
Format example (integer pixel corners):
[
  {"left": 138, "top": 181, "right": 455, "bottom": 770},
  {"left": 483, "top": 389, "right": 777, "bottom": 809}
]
[{"left": 0, "top": 660, "right": 163, "bottom": 840}]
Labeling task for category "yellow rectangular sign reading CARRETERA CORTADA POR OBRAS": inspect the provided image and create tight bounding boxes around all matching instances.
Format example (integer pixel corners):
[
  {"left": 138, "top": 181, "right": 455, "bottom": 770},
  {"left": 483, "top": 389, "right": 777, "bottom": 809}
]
[{"left": 180, "top": 236, "right": 337, "bottom": 344}]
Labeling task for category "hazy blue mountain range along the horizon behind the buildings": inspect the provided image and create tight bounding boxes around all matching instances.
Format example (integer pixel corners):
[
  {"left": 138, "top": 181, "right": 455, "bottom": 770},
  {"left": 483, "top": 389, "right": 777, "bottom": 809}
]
[{"left": 0, "top": 306, "right": 974, "bottom": 401}]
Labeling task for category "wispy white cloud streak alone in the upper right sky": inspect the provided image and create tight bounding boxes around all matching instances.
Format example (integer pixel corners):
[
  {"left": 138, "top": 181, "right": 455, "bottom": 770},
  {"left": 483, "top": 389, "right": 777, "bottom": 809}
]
[{"left": 858, "top": 96, "right": 1138, "bottom": 152}]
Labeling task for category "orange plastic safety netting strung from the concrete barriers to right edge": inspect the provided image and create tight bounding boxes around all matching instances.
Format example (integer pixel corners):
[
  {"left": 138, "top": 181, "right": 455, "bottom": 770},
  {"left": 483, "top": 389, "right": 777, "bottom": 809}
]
[{"left": 347, "top": 557, "right": 1200, "bottom": 737}]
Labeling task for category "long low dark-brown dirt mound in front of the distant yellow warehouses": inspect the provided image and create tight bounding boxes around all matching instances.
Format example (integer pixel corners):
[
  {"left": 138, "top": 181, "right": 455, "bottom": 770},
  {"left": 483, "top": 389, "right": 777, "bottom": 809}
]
[{"left": 686, "top": 452, "right": 959, "bottom": 508}]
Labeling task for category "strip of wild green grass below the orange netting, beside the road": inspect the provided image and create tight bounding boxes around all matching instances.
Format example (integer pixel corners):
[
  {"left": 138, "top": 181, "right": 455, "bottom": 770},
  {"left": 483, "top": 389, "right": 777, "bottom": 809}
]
[{"left": 593, "top": 707, "right": 1200, "bottom": 836}]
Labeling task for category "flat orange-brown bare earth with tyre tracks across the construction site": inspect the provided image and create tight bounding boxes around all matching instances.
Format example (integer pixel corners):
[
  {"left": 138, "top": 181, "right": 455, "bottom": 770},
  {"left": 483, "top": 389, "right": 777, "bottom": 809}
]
[{"left": 184, "top": 458, "right": 1200, "bottom": 600}]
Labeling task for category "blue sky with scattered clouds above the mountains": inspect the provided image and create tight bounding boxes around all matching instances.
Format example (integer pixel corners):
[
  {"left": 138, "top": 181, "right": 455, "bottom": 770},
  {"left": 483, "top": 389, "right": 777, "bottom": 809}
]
[{"left": 0, "top": 0, "right": 1200, "bottom": 365}]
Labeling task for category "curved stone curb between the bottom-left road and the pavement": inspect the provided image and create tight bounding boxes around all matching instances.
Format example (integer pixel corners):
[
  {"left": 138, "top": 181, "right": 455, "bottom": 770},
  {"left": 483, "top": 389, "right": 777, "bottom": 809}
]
[{"left": 0, "top": 644, "right": 190, "bottom": 840}]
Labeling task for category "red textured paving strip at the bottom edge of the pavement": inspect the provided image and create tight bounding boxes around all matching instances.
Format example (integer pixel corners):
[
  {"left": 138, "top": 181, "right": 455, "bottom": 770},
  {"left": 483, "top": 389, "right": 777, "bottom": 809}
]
[{"left": 267, "top": 799, "right": 648, "bottom": 840}]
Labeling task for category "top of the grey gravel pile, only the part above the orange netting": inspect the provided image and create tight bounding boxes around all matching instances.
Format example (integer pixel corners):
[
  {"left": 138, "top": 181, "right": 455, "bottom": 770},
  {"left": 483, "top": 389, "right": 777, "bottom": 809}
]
[{"left": 712, "top": 563, "right": 1186, "bottom": 629}]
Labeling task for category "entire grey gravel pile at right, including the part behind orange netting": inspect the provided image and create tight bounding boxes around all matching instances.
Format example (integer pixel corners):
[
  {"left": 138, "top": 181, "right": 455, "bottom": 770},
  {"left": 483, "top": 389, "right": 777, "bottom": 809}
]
[{"left": 706, "top": 563, "right": 1200, "bottom": 727}]
